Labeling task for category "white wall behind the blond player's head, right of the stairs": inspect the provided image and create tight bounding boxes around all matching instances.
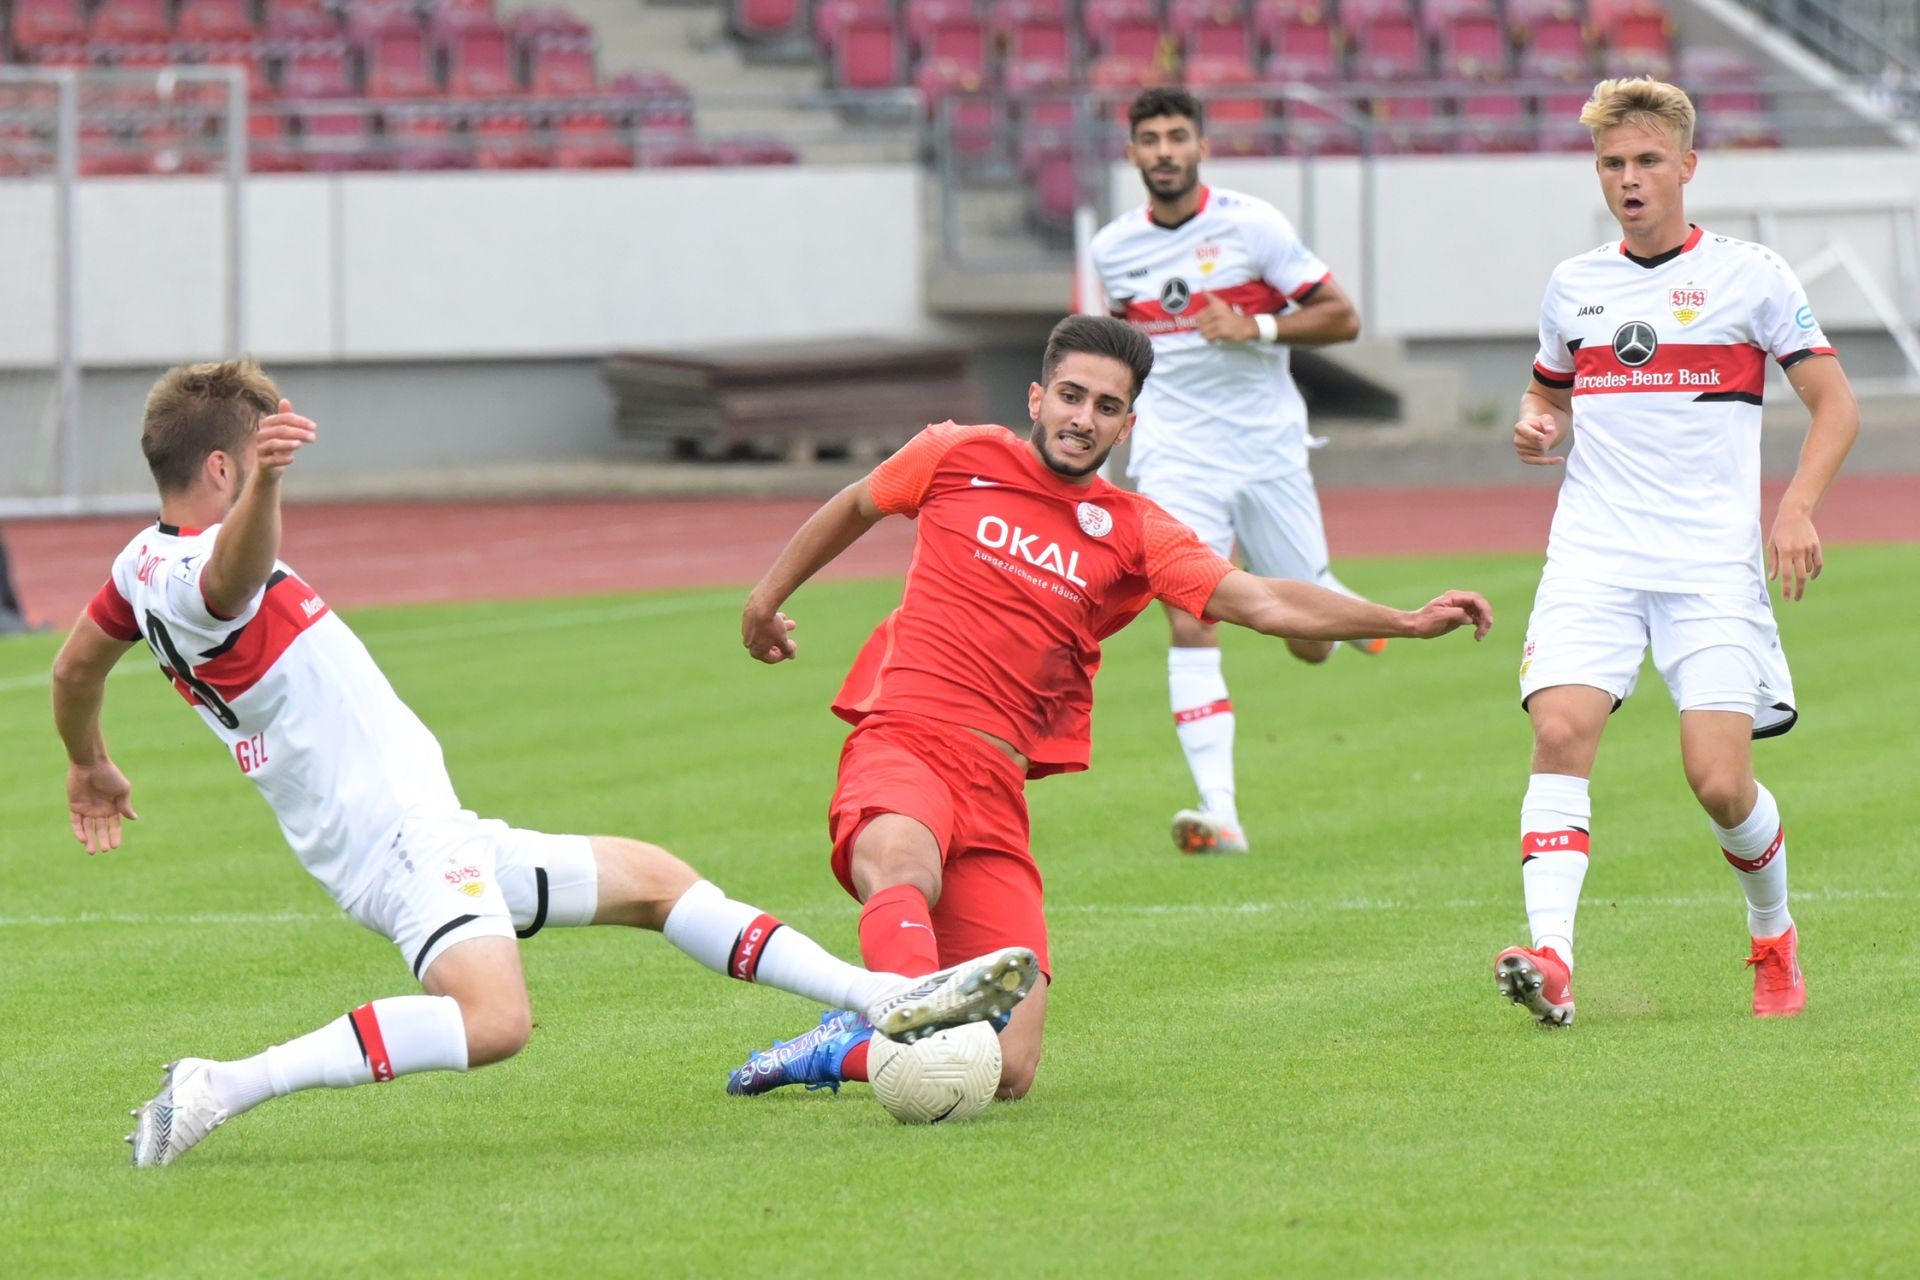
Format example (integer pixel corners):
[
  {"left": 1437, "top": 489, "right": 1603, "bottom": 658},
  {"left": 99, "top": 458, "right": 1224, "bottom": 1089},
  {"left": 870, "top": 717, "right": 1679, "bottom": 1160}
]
[{"left": 1112, "top": 150, "right": 1920, "bottom": 338}]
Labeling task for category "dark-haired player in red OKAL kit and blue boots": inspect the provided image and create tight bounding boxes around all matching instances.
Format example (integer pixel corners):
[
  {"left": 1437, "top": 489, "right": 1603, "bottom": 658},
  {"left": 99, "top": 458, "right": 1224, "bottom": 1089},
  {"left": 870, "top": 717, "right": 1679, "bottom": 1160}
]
[{"left": 728, "top": 315, "right": 1492, "bottom": 1098}]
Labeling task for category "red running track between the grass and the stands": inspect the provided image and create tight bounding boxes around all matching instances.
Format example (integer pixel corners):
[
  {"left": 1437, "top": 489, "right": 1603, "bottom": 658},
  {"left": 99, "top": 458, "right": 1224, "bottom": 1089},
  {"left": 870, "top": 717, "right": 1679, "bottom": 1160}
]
[{"left": 4, "top": 476, "right": 1920, "bottom": 626}]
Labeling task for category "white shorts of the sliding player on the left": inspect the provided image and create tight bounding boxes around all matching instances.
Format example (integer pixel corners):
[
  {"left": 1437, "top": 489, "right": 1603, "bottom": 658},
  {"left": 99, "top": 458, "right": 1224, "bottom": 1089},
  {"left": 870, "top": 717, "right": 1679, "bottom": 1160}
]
[{"left": 346, "top": 810, "right": 599, "bottom": 979}]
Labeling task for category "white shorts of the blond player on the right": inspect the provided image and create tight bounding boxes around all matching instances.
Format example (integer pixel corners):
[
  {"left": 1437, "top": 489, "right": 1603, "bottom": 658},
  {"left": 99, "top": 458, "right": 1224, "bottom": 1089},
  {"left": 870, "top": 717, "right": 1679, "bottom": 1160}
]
[{"left": 1521, "top": 576, "right": 1799, "bottom": 737}]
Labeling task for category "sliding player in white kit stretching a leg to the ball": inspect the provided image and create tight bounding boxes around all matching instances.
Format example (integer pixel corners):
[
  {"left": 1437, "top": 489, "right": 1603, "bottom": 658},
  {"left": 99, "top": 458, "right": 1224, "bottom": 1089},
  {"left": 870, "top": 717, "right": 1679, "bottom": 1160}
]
[{"left": 54, "top": 361, "right": 1037, "bottom": 1167}]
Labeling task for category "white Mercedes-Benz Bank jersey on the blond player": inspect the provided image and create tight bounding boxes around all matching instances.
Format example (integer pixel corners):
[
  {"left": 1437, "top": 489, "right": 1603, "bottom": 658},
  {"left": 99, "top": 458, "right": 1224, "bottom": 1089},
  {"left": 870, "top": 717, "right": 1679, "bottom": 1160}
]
[{"left": 1534, "top": 226, "right": 1834, "bottom": 591}]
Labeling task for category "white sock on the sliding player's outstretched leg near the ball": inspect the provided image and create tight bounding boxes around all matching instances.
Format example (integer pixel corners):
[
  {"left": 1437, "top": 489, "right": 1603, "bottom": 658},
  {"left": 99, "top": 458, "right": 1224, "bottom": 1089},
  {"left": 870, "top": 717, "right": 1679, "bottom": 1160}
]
[{"left": 660, "top": 881, "right": 900, "bottom": 1013}]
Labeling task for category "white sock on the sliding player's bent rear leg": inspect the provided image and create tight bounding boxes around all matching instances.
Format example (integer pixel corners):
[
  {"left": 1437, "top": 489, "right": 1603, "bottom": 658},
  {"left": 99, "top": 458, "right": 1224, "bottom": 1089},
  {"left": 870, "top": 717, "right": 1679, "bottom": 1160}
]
[{"left": 209, "top": 996, "right": 467, "bottom": 1115}]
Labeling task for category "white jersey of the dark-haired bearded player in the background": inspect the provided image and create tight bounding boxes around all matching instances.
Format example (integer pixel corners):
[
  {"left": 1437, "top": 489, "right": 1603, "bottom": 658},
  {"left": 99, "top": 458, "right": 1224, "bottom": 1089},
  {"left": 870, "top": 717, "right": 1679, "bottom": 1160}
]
[{"left": 1092, "top": 186, "right": 1331, "bottom": 480}]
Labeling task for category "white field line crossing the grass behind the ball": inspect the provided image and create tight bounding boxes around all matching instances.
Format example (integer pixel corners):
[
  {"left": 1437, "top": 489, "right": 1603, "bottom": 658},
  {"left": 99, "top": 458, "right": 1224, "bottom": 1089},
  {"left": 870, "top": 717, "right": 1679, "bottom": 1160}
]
[{"left": 0, "top": 889, "right": 1889, "bottom": 929}]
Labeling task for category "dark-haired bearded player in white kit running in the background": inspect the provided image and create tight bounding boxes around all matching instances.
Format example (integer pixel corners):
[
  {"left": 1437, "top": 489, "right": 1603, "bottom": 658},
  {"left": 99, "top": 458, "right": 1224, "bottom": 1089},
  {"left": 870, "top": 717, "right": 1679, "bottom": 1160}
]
[{"left": 1092, "top": 88, "right": 1386, "bottom": 854}]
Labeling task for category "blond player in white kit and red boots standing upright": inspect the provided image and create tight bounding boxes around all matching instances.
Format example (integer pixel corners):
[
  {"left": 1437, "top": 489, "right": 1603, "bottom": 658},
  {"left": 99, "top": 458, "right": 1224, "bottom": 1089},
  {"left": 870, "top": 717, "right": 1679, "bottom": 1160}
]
[{"left": 1494, "top": 79, "right": 1860, "bottom": 1025}]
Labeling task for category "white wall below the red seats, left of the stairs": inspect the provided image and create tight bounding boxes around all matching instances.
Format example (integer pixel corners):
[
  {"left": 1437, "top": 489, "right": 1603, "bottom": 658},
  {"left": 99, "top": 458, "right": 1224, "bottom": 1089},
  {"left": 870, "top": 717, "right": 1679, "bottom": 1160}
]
[{"left": 0, "top": 167, "right": 929, "bottom": 367}]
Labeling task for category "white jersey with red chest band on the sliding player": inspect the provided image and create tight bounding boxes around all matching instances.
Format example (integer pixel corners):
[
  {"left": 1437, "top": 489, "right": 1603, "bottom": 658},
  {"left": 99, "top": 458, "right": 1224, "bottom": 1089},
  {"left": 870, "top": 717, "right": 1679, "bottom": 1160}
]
[{"left": 86, "top": 524, "right": 461, "bottom": 906}]
